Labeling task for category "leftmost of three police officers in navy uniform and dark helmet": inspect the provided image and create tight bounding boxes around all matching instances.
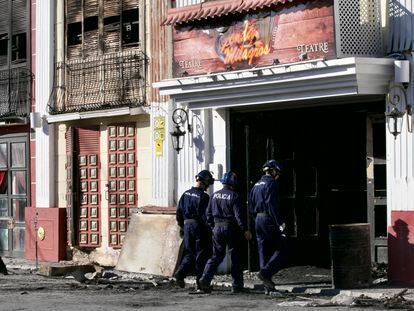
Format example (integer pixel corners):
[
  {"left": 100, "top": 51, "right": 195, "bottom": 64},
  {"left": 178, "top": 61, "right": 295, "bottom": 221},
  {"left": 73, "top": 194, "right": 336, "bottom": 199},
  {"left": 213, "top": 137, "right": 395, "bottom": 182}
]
[{"left": 174, "top": 170, "right": 214, "bottom": 288}]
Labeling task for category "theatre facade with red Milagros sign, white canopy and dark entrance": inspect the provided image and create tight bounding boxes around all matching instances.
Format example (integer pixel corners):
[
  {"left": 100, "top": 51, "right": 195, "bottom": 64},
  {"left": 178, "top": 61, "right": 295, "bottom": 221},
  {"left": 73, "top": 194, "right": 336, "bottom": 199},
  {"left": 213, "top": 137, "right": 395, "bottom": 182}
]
[{"left": 154, "top": 0, "right": 413, "bottom": 274}]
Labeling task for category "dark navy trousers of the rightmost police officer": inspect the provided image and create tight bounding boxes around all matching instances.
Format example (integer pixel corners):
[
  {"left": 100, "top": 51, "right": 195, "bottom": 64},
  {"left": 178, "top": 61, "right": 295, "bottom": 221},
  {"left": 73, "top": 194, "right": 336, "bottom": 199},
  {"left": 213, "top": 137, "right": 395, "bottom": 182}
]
[{"left": 256, "top": 216, "right": 287, "bottom": 278}]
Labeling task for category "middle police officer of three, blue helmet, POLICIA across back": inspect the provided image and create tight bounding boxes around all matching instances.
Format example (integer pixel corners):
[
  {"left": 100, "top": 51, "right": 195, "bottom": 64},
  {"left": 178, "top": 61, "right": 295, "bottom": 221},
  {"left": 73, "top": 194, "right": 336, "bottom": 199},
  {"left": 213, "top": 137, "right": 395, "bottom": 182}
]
[{"left": 200, "top": 172, "right": 252, "bottom": 293}]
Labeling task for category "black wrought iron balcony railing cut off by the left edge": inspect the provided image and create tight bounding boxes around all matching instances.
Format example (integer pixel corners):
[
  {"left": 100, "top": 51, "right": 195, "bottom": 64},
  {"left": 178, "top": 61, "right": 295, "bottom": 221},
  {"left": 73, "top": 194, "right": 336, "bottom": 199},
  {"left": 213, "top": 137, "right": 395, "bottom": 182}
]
[{"left": 0, "top": 67, "right": 32, "bottom": 120}]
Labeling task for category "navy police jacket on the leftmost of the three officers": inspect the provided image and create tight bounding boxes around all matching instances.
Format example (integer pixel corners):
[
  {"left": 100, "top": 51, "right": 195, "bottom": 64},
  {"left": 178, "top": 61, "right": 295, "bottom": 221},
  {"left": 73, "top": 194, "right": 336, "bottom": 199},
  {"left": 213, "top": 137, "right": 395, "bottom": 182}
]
[{"left": 176, "top": 187, "right": 209, "bottom": 227}]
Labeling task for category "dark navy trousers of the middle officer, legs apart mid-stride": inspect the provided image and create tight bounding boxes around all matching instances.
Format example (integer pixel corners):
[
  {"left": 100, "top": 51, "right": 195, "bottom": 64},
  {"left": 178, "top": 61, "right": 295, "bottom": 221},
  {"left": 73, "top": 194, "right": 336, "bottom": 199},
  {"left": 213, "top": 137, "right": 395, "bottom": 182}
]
[{"left": 203, "top": 224, "right": 244, "bottom": 288}]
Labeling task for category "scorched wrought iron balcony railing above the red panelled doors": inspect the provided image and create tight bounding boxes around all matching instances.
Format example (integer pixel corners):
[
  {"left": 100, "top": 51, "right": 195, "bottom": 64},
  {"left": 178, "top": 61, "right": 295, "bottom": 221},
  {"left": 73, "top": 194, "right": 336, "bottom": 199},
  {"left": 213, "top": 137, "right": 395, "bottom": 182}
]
[{"left": 49, "top": 50, "right": 147, "bottom": 114}]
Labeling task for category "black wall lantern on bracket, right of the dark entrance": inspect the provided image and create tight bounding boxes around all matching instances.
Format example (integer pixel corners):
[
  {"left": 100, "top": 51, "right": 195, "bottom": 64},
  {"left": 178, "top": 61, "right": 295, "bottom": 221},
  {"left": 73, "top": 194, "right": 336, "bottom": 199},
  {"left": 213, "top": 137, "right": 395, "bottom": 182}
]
[{"left": 385, "top": 85, "right": 412, "bottom": 139}]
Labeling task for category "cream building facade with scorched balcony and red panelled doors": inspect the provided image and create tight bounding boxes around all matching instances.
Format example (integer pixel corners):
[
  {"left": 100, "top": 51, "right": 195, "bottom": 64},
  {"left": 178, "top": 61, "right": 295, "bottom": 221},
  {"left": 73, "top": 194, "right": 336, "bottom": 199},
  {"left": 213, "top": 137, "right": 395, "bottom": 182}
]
[{"left": 26, "top": 0, "right": 172, "bottom": 265}]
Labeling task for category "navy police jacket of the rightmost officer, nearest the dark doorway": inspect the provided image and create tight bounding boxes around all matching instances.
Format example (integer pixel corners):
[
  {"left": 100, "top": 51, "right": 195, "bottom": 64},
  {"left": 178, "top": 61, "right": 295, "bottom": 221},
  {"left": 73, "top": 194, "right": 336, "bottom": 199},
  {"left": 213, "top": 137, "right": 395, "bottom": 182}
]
[{"left": 249, "top": 175, "right": 283, "bottom": 225}]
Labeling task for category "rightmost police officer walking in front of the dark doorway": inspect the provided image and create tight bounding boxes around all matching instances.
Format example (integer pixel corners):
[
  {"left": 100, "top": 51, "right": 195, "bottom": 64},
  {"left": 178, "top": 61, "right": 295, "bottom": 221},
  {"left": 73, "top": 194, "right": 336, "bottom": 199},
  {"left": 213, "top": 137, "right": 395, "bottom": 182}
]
[{"left": 249, "top": 160, "right": 286, "bottom": 293}]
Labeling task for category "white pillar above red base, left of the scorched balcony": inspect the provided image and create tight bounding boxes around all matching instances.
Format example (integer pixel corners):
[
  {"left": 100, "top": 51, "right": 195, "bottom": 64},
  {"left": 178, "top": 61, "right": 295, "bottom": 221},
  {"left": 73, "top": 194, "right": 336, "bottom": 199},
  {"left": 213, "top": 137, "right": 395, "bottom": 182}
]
[{"left": 35, "top": 0, "right": 55, "bottom": 207}]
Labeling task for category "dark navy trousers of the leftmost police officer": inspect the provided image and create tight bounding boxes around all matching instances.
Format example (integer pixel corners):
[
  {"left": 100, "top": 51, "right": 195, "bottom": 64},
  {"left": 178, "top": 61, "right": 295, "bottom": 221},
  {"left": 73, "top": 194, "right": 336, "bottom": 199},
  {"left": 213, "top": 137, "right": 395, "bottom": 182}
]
[{"left": 176, "top": 223, "right": 211, "bottom": 280}]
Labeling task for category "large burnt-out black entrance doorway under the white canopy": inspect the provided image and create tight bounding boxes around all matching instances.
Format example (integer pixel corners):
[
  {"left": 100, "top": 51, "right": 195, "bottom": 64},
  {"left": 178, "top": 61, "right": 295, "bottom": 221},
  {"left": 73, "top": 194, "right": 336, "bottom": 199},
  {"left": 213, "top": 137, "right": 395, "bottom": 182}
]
[{"left": 231, "top": 102, "right": 385, "bottom": 269}]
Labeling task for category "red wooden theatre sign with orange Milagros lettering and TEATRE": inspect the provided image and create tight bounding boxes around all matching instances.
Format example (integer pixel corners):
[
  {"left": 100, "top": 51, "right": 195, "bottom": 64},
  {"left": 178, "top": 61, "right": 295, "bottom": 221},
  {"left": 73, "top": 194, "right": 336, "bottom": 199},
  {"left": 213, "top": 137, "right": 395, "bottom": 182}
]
[{"left": 174, "top": 0, "right": 335, "bottom": 77}]
